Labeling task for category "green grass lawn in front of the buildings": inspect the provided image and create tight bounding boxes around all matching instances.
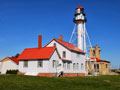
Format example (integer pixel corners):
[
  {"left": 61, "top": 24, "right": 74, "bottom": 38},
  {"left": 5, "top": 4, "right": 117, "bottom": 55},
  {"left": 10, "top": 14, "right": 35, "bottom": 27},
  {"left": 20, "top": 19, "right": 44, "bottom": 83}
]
[{"left": 0, "top": 75, "right": 120, "bottom": 90}]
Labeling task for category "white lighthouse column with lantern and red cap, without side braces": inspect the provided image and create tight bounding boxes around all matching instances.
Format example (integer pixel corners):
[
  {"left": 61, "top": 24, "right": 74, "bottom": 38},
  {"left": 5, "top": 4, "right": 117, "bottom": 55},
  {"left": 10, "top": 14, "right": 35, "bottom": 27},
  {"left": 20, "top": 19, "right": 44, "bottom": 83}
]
[{"left": 73, "top": 5, "right": 87, "bottom": 51}]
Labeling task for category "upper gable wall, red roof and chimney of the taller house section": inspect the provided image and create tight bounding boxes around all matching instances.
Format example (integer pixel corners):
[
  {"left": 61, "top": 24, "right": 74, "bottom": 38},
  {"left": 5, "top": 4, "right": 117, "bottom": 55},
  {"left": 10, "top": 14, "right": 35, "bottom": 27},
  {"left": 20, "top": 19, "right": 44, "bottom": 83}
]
[{"left": 45, "top": 35, "right": 85, "bottom": 61}]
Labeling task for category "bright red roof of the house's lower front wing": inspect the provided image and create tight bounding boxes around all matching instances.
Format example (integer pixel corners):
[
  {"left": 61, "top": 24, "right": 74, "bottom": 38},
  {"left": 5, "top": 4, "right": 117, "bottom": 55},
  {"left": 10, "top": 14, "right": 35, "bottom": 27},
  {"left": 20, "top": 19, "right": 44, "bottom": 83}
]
[{"left": 18, "top": 47, "right": 55, "bottom": 60}]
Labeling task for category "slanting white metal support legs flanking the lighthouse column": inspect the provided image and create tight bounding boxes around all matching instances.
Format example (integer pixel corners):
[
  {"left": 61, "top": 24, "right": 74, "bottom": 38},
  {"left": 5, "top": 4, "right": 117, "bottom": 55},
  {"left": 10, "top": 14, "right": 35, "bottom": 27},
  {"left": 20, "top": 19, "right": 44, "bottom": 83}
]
[{"left": 69, "top": 23, "right": 97, "bottom": 76}]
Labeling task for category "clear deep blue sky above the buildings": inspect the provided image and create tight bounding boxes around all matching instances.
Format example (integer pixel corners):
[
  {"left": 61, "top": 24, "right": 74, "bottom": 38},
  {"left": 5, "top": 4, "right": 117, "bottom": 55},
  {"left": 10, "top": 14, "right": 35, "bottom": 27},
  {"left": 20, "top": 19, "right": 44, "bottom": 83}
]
[{"left": 0, "top": 0, "right": 120, "bottom": 68}]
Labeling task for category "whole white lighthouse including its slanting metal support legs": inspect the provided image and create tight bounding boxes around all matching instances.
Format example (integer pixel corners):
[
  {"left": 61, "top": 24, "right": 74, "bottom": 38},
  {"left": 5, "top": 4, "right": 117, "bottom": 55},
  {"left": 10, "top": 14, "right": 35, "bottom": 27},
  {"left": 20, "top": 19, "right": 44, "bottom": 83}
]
[{"left": 69, "top": 5, "right": 97, "bottom": 75}]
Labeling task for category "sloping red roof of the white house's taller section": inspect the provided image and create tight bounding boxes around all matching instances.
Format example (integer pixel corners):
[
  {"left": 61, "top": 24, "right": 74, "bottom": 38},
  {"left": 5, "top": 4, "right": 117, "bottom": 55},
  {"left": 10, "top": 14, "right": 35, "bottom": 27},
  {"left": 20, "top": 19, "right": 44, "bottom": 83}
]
[{"left": 46, "top": 39, "right": 85, "bottom": 54}]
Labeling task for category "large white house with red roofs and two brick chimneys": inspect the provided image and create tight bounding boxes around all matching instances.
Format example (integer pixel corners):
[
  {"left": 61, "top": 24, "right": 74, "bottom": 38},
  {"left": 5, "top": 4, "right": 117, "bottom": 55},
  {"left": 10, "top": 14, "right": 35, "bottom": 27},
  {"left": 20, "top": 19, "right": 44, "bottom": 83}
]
[{"left": 18, "top": 35, "right": 86, "bottom": 76}]
